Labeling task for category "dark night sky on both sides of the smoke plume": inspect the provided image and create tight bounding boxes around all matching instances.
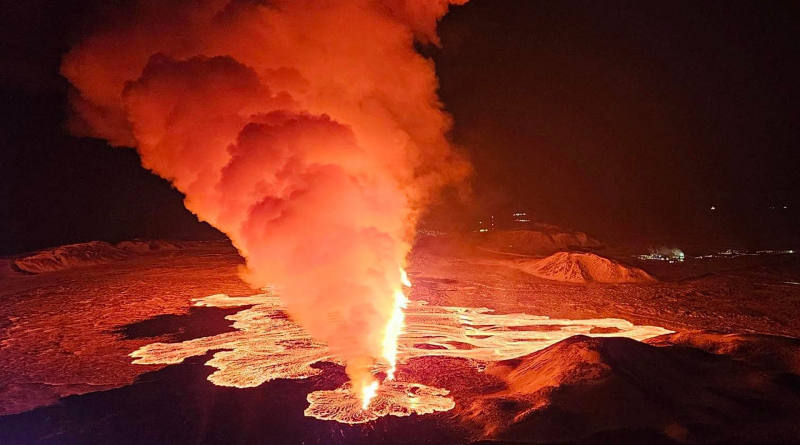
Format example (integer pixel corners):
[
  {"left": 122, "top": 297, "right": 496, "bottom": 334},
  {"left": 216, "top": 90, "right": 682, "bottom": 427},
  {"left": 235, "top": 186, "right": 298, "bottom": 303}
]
[{"left": 0, "top": 0, "right": 800, "bottom": 253}]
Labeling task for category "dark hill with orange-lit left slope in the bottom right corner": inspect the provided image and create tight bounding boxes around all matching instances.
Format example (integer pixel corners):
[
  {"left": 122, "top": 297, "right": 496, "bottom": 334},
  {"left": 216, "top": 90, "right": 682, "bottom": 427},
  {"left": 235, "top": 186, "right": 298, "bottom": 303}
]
[{"left": 466, "top": 333, "right": 800, "bottom": 443}]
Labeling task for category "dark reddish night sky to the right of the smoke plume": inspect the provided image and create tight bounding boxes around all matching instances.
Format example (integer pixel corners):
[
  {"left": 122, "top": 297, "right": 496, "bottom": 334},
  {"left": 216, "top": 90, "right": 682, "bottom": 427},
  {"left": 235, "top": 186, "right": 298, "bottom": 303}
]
[{"left": 435, "top": 0, "right": 800, "bottom": 246}]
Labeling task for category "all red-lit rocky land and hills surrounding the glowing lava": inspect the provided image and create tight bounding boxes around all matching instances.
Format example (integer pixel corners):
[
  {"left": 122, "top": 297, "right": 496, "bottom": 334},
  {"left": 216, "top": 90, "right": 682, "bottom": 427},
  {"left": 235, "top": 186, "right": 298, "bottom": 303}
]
[{"left": 0, "top": 234, "right": 800, "bottom": 445}]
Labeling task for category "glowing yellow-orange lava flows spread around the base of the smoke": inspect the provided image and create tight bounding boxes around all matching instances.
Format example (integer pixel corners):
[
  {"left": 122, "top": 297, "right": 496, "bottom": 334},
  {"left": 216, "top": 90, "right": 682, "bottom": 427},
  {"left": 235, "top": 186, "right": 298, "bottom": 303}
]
[{"left": 131, "top": 292, "right": 672, "bottom": 423}]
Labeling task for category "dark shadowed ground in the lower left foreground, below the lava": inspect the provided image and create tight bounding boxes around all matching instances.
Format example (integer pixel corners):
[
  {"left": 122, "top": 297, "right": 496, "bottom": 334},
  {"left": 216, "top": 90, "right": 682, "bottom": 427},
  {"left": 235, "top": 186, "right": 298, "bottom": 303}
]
[{"left": 0, "top": 354, "right": 464, "bottom": 445}]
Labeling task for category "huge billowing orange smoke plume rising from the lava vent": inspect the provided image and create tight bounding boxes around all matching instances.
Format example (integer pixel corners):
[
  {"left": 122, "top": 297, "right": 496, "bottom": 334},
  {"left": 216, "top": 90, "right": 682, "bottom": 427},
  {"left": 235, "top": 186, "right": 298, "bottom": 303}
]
[{"left": 62, "top": 0, "right": 469, "bottom": 396}]
